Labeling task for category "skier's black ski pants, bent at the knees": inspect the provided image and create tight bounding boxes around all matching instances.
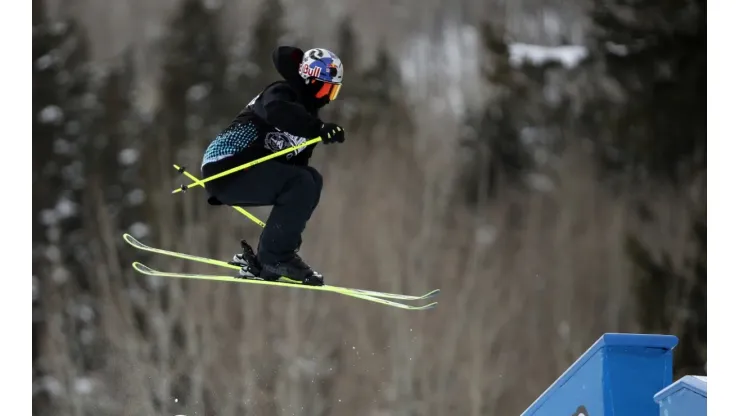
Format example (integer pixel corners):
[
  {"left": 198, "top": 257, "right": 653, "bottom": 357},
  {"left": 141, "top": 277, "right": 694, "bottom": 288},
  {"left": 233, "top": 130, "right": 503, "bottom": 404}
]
[{"left": 204, "top": 161, "right": 323, "bottom": 264}]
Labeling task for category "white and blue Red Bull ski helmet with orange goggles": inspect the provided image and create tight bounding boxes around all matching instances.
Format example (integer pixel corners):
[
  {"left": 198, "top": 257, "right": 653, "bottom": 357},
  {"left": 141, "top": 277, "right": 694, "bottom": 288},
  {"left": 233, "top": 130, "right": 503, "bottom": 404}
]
[{"left": 298, "top": 48, "right": 344, "bottom": 101}]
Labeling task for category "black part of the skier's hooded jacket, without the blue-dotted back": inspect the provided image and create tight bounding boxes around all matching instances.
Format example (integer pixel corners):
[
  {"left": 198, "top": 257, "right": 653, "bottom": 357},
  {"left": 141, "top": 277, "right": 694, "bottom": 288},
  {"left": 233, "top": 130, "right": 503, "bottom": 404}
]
[{"left": 203, "top": 46, "right": 328, "bottom": 176}]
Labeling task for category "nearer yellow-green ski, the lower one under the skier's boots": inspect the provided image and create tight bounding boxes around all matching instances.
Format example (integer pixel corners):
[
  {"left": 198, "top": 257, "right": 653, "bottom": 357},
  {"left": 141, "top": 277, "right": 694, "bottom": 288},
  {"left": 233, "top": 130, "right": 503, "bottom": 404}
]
[{"left": 133, "top": 261, "right": 437, "bottom": 311}]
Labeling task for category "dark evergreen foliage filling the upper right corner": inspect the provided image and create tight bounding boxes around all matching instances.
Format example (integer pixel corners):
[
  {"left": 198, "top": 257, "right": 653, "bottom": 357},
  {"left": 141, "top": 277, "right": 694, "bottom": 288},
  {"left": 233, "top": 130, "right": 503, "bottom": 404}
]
[{"left": 593, "top": 0, "right": 707, "bottom": 183}]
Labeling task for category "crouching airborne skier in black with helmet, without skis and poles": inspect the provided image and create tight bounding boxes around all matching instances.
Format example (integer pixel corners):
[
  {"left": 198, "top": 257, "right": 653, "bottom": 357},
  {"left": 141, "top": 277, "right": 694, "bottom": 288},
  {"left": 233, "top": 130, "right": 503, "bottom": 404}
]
[{"left": 201, "top": 46, "right": 344, "bottom": 286}]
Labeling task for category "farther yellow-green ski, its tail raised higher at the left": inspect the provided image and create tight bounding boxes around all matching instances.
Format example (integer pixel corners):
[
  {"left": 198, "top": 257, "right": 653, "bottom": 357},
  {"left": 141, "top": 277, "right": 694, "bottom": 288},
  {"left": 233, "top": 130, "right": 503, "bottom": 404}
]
[{"left": 123, "top": 234, "right": 440, "bottom": 305}]
